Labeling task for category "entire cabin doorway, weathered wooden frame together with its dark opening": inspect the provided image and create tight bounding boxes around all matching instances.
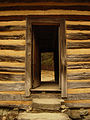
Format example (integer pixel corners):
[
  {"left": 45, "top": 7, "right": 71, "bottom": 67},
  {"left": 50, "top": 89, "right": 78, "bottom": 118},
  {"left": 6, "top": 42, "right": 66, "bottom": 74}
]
[{"left": 25, "top": 16, "right": 67, "bottom": 97}]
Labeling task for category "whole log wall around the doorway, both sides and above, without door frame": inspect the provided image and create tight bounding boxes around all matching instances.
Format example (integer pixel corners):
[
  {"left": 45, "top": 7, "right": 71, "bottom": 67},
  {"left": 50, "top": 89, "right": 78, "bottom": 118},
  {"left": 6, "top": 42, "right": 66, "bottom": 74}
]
[{"left": 0, "top": 0, "right": 90, "bottom": 107}]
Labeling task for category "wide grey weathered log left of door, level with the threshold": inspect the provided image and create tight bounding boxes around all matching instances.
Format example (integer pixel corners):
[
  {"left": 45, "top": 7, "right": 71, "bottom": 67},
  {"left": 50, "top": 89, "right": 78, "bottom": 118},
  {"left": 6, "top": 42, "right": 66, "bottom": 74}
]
[{"left": 0, "top": 82, "right": 25, "bottom": 91}]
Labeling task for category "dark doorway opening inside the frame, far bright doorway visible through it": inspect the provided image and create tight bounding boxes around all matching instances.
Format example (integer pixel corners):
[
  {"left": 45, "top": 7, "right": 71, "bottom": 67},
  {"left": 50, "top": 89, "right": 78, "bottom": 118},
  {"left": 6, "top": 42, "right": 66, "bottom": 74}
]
[{"left": 32, "top": 25, "right": 59, "bottom": 89}]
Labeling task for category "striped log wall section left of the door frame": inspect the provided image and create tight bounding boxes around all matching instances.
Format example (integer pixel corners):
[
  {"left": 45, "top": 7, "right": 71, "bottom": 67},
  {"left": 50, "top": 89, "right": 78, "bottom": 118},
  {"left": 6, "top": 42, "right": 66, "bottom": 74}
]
[{"left": 0, "top": 20, "right": 30, "bottom": 107}]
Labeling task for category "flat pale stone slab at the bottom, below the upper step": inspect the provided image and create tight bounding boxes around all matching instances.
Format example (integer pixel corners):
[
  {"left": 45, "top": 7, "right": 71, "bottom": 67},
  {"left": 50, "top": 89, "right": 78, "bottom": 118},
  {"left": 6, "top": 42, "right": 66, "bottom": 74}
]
[{"left": 18, "top": 112, "right": 71, "bottom": 120}]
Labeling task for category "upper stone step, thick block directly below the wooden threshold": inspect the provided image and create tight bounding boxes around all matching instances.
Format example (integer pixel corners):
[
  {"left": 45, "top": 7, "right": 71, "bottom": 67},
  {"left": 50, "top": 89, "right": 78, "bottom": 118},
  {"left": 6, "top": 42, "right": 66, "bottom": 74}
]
[{"left": 32, "top": 98, "right": 64, "bottom": 111}]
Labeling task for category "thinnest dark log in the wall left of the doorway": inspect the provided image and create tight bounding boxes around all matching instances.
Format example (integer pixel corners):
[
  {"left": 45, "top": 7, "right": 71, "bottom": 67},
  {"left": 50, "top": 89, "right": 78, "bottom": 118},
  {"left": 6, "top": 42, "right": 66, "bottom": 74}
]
[{"left": 0, "top": 65, "right": 25, "bottom": 72}]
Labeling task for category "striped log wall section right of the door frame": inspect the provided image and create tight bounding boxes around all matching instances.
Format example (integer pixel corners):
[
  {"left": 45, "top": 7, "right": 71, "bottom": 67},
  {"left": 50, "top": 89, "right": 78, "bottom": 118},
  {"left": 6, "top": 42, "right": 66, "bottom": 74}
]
[{"left": 66, "top": 20, "right": 90, "bottom": 107}]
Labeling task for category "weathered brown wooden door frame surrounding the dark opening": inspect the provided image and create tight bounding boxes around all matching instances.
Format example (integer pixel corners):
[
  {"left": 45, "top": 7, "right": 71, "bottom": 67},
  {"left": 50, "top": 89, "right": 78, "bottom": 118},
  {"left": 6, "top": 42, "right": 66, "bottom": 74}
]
[{"left": 25, "top": 16, "right": 67, "bottom": 98}]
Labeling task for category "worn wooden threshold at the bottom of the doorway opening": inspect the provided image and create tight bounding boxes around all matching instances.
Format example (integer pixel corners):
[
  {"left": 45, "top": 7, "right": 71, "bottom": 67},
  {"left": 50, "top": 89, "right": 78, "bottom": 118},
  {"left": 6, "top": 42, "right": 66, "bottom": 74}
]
[{"left": 31, "top": 82, "right": 61, "bottom": 92}]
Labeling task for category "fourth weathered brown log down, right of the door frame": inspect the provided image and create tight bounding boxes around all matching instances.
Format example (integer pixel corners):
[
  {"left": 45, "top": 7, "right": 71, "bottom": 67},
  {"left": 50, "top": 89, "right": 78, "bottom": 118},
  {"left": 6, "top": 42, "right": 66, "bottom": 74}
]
[{"left": 67, "top": 54, "right": 90, "bottom": 62}]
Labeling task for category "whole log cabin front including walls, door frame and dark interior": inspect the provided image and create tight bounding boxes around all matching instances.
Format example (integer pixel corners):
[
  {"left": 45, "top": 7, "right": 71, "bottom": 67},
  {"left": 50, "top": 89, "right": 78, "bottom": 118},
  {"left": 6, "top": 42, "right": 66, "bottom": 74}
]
[{"left": 0, "top": 0, "right": 90, "bottom": 108}]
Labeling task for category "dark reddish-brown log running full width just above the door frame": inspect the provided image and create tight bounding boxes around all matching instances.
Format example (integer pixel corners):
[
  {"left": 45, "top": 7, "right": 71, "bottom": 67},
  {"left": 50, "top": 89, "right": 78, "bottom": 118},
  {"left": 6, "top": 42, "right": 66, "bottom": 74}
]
[{"left": 0, "top": 15, "right": 90, "bottom": 21}]
